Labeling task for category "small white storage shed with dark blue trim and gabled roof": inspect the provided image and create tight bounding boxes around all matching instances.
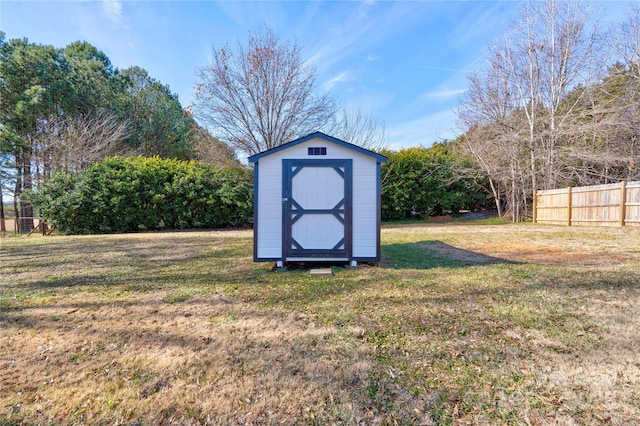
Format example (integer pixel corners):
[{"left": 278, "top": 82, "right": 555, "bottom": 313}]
[{"left": 249, "top": 132, "right": 387, "bottom": 266}]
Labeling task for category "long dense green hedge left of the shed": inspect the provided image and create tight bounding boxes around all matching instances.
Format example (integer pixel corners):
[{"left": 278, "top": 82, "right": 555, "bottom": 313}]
[{"left": 29, "top": 157, "right": 253, "bottom": 234}]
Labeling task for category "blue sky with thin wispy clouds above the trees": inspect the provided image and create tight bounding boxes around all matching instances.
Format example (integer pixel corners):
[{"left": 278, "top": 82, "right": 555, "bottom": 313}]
[{"left": 0, "top": 0, "right": 626, "bottom": 149}]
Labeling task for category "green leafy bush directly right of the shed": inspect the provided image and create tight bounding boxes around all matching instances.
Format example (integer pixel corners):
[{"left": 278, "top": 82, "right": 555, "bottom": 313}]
[{"left": 382, "top": 143, "right": 491, "bottom": 220}]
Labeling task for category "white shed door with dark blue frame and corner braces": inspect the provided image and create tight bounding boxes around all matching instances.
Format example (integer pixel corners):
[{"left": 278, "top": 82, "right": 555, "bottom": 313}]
[{"left": 282, "top": 159, "right": 352, "bottom": 261}]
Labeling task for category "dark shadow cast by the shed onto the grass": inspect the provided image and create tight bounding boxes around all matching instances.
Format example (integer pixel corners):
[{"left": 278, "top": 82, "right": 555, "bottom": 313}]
[{"left": 380, "top": 240, "right": 517, "bottom": 269}]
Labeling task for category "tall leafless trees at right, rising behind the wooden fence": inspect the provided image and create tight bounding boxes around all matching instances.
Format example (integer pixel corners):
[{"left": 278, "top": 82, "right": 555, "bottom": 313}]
[{"left": 459, "top": 0, "right": 640, "bottom": 220}]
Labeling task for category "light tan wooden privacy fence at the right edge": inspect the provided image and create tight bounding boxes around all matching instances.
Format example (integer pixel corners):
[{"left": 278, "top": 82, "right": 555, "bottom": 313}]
[{"left": 533, "top": 181, "right": 640, "bottom": 226}]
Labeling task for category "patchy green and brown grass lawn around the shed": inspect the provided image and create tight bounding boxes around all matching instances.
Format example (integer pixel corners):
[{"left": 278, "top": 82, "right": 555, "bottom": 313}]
[{"left": 0, "top": 222, "right": 640, "bottom": 425}]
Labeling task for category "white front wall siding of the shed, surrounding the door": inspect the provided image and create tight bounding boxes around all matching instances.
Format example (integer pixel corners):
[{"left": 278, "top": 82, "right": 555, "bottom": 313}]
[{"left": 257, "top": 138, "right": 378, "bottom": 259}]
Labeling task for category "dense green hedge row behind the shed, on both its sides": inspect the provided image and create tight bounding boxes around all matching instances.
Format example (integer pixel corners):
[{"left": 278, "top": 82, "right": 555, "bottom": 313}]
[{"left": 23, "top": 142, "right": 491, "bottom": 234}]
